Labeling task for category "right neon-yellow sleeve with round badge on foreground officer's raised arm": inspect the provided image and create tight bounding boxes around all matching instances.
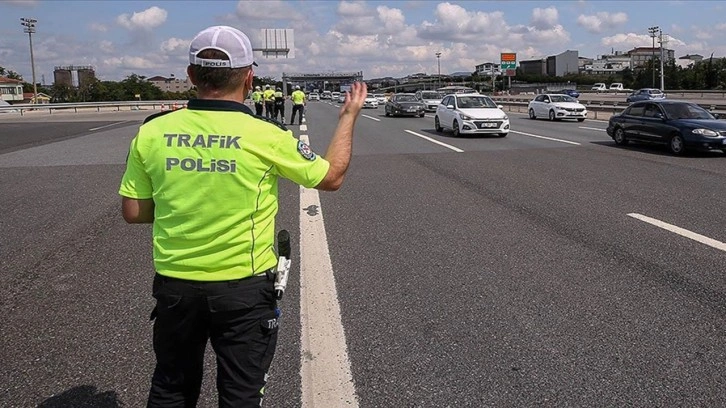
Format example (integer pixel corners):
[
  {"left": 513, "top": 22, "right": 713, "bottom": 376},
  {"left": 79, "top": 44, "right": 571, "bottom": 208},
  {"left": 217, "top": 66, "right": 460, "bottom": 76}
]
[{"left": 274, "top": 135, "right": 330, "bottom": 188}]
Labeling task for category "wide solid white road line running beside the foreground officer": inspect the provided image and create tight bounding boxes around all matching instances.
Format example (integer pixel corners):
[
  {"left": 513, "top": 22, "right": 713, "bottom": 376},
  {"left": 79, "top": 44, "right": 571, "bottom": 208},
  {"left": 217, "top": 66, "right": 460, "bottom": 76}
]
[{"left": 300, "top": 135, "right": 358, "bottom": 408}]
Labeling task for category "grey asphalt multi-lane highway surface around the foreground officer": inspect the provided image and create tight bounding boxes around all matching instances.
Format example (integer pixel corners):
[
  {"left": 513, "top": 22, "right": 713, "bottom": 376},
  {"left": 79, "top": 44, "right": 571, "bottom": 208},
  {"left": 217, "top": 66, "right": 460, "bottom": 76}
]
[{"left": 0, "top": 101, "right": 726, "bottom": 408}]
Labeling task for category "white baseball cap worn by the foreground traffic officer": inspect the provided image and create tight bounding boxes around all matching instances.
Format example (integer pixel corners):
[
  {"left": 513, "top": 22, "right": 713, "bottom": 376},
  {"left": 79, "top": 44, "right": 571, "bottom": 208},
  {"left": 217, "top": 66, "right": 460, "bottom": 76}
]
[{"left": 189, "top": 26, "right": 257, "bottom": 68}]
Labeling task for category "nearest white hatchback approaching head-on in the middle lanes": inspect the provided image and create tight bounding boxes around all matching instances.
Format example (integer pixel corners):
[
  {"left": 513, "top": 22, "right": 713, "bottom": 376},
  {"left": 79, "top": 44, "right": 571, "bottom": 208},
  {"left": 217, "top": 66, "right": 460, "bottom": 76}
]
[{"left": 434, "top": 93, "right": 509, "bottom": 137}]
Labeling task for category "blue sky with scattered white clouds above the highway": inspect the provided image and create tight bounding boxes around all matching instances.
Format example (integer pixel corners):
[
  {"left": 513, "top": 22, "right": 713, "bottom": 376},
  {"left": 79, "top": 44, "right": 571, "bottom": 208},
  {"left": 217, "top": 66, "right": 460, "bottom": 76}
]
[{"left": 0, "top": 0, "right": 726, "bottom": 84}]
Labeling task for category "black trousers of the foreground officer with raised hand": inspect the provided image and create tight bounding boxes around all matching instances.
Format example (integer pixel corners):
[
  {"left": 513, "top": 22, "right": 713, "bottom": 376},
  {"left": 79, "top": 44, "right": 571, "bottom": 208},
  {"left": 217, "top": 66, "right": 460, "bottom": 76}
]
[{"left": 147, "top": 272, "right": 278, "bottom": 408}]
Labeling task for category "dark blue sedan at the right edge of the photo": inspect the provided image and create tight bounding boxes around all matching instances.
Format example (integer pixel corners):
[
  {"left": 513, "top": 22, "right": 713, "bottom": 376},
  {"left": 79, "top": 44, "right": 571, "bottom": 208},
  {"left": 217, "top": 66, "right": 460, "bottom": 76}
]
[{"left": 607, "top": 99, "right": 726, "bottom": 155}]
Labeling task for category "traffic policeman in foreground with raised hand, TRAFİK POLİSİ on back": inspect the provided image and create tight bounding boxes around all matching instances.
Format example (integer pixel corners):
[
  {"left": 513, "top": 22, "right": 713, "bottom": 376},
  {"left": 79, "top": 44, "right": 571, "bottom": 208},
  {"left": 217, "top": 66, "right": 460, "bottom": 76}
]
[{"left": 119, "top": 26, "right": 367, "bottom": 408}]
